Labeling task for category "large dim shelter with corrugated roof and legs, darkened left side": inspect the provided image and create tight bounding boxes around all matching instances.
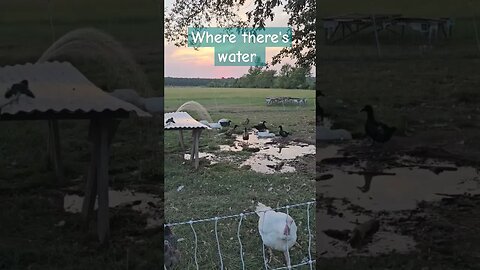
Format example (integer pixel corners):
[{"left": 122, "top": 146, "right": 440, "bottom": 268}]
[{"left": 0, "top": 62, "right": 151, "bottom": 244}]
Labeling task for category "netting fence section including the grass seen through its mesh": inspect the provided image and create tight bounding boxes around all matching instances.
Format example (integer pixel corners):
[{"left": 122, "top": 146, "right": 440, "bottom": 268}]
[{"left": 164, "top": 201, "right": 316, "bottom": 270}]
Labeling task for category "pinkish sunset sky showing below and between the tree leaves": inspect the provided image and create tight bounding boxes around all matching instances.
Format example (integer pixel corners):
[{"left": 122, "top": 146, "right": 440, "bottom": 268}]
[{"left": 165, "top": 0, "right": 304, "bottom": 78}]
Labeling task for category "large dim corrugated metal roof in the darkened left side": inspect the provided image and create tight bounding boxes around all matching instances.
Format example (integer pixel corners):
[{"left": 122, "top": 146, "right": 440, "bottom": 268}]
[{"left": 0, "top": 62, "right": 151, "bottom": 117}]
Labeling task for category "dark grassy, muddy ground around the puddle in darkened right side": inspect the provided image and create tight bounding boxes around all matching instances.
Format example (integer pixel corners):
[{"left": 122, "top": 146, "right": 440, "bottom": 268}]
[{"left": 317, "top": 31, "right": 480, "bottom": 270}]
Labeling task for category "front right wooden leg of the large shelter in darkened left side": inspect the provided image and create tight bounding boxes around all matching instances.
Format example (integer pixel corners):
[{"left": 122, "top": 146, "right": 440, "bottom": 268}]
[{"left": 97, "top": 119, "right": 112, "bottom": 245}]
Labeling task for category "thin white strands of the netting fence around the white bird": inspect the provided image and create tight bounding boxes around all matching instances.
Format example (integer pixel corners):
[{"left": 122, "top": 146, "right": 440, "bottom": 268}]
[{"left": 164, "top": 201, "right": 316, "bottom": 270}]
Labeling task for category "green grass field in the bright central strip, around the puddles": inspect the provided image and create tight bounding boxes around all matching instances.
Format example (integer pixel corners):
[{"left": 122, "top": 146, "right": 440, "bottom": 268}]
[{"left": 165, "top": 88, "right": 315, "bottom": 269}]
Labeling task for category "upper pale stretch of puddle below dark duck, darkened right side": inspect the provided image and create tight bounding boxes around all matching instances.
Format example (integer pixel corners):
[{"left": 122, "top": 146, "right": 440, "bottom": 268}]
[{"left": 318, "top": 168, "right": 480, "bottom": 211}]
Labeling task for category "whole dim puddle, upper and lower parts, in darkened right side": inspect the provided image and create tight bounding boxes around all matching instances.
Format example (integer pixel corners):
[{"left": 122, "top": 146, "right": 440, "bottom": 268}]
[{"left": 317, "top": 146, "right": 480, "bottom": 257}]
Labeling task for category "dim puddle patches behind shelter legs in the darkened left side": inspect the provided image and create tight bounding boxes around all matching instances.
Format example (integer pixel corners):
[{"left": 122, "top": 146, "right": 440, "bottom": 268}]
[{"left": 63, "top": 190, "right": 162, "bottom": 228}]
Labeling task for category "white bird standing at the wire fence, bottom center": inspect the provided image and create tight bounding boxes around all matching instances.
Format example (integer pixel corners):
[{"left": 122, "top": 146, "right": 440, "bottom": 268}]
[{"left": 255, "top": 203, "right": 297, "bottom": 268}]
